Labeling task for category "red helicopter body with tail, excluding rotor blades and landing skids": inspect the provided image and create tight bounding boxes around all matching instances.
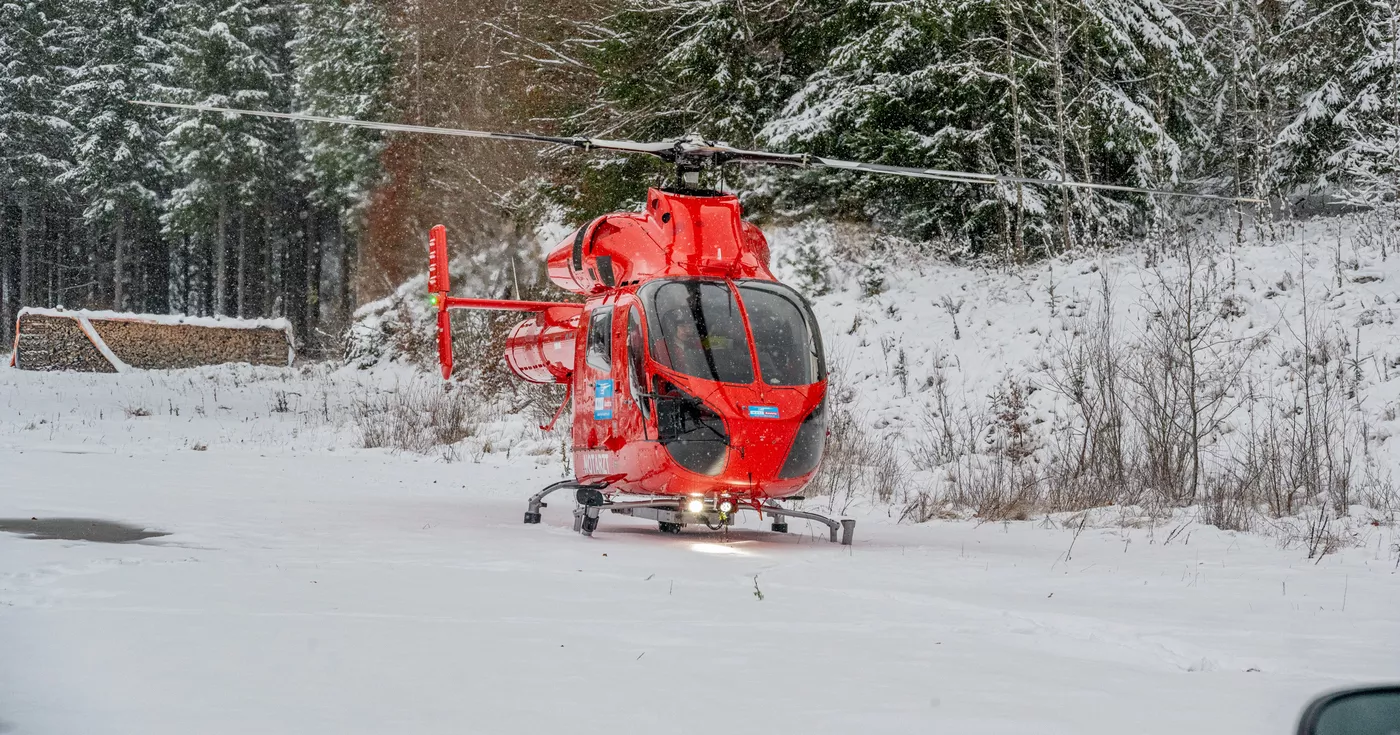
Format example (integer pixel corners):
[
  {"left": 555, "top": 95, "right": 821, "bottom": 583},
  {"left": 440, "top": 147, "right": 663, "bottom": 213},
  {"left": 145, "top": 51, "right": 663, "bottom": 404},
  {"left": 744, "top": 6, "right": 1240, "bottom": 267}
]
[{"left": 430, "top": 189, "right": 826, "bottom": 507}]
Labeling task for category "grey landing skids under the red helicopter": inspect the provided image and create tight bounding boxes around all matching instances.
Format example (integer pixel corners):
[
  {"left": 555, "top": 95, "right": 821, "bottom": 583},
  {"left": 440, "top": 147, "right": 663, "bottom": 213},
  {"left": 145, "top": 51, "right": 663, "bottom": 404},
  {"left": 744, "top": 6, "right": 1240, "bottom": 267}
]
[{"left": 525, "top": 480, "right": 855, "bottom": 546}]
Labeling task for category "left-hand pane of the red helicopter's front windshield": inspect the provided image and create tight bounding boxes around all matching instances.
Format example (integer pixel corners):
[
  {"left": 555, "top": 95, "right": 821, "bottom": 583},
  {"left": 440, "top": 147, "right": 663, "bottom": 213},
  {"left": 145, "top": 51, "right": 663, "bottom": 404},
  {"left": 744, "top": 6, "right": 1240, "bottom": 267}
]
[{"left": 645, "top": 280, "right": 753, "bottom": 384}]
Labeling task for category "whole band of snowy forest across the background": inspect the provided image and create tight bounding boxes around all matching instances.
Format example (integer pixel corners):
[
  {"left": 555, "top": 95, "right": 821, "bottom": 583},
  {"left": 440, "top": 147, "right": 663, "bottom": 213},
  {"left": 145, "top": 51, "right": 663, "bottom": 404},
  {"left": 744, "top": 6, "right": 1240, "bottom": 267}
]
[{"left": 0, "top": 0, "right": 1400, "bottom": 354}]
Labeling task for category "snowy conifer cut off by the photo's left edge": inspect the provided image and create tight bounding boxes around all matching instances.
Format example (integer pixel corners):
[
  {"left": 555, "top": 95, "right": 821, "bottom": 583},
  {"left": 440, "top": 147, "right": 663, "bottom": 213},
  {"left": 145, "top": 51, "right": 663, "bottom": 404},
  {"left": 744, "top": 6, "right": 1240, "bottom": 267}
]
[{"left": 0, "top": 0, "right": 73, "bottom": 335}]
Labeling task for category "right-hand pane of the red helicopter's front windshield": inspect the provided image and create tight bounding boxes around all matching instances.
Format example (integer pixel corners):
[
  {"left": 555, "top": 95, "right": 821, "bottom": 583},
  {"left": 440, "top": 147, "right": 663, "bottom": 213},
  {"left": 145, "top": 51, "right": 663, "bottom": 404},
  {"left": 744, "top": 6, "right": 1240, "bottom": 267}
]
[{"left": 739, "top": 281, "right": 826, "bottom": 385}]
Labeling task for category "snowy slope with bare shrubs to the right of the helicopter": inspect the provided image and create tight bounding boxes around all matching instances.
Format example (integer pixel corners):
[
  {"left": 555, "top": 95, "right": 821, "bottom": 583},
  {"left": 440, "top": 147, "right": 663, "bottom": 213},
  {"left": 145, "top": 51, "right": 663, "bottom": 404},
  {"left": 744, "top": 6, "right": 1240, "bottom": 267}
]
[{"left": 774, "top": 220, "right": 1400, "bottom": 545}]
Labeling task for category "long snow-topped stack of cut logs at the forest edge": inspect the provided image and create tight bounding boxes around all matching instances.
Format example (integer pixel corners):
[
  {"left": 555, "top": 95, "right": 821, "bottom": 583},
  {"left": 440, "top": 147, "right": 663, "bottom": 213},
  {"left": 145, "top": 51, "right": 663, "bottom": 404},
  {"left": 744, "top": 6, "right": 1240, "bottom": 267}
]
[{"left": 13, "top": 309, "right": 293, "bottom": 372}]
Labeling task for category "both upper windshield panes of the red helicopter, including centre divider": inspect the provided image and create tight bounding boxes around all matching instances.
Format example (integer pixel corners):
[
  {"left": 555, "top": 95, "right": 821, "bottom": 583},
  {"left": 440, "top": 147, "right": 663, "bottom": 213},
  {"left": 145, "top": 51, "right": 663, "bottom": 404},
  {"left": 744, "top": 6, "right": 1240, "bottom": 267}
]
[{"left": 643, "top": 279, "right": 826, "bottom": 386}]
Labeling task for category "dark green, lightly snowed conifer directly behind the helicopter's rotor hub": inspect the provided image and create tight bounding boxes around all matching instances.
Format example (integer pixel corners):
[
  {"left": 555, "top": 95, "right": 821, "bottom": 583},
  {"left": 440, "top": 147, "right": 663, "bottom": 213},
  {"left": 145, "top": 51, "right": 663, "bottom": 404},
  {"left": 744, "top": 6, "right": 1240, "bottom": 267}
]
[{"left": 556, "top": 0, "right": 823, "bottom": 218}]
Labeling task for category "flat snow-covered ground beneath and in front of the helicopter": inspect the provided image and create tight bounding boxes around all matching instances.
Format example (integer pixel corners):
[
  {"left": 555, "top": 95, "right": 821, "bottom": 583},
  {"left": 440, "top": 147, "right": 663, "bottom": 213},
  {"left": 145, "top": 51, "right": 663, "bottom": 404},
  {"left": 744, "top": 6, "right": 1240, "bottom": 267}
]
[{"left": 0, "top": 357, "right": 1400, "bottom": 735}]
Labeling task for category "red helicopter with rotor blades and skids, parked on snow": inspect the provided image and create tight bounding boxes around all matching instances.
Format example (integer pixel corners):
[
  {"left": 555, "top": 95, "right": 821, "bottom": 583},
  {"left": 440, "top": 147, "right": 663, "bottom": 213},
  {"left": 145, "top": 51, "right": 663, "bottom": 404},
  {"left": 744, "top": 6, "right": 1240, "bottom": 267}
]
[{"left": 133, "top": 101, "right": 1261, "bottom": 545}]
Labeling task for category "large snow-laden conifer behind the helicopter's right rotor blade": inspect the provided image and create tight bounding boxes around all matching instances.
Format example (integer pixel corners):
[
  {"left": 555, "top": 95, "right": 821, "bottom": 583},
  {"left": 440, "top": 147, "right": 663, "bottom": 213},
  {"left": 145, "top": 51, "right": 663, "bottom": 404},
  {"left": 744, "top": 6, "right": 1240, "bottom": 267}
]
[{"left": 764, "top": 0, "right": 1203, "bottom": 252}]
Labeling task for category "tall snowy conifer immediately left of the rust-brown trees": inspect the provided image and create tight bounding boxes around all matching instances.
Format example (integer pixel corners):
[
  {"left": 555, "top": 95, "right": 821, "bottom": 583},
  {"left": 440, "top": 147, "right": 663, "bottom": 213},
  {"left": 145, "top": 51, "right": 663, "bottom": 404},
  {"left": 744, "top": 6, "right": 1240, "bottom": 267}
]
[{"left": 291, "top": 0, "right": 393, "bottom": 326}]
